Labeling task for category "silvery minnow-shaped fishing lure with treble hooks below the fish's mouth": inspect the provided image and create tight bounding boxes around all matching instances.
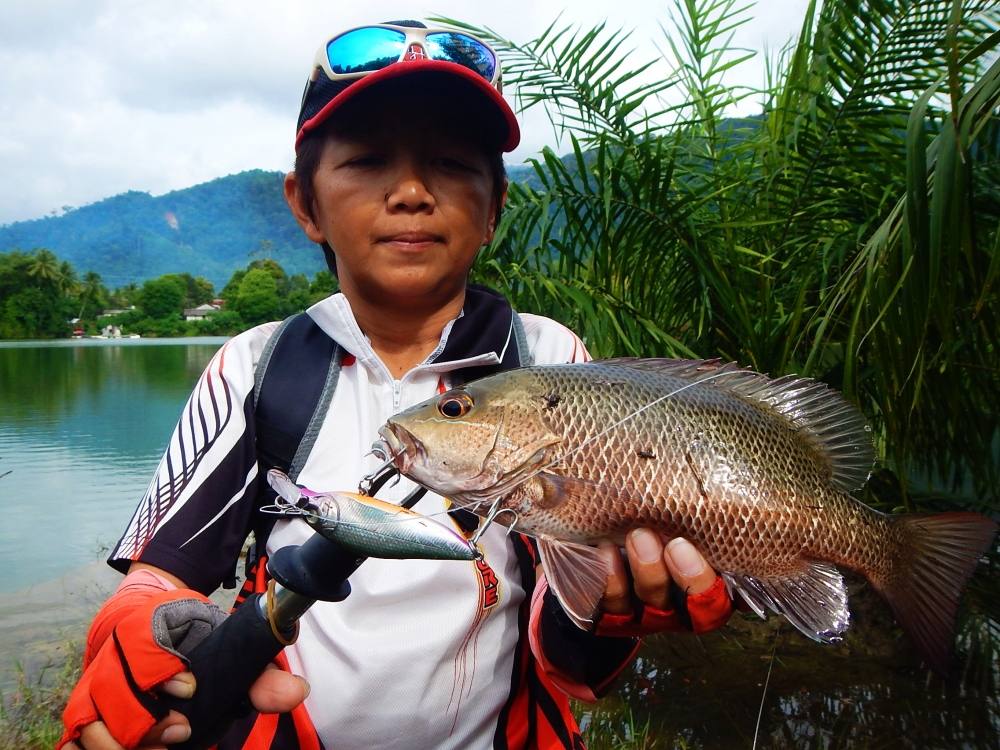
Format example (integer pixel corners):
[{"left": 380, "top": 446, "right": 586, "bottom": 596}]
[{"left": 264, "top": 469, "right": 479, "bottom": 560}]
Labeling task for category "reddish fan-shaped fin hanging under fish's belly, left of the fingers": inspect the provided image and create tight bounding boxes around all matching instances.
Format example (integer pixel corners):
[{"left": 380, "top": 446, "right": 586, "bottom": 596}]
[{"left": 538, "top": 536, "right": 608, "bottom": 631}]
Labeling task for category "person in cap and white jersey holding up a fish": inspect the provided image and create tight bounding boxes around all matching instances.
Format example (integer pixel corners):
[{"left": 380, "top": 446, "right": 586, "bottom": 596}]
[{"left": 64, "top": 22, "right": 730, "bottom": 750}]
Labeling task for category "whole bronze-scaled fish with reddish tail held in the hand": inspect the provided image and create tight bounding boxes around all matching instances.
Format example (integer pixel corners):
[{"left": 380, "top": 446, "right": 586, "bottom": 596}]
[{"left": 379, "top": 358, "right": 997, "bottom": 672}]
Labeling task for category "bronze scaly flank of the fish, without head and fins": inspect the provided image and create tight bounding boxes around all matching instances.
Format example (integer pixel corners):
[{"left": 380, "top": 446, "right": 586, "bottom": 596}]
[{"left": 504, "top": 365, "right": 886, "bottom": 576}]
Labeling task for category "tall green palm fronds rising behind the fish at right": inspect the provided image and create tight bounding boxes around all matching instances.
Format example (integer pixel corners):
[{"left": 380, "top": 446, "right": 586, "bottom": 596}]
[{"left": 464, "top": 0, "right": 1000, "bottom": 503}]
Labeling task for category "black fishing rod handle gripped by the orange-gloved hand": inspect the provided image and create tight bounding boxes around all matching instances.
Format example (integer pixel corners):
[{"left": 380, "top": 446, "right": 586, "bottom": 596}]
[{"left": 163, "top": 462, "right": 414, "bottom": 750}]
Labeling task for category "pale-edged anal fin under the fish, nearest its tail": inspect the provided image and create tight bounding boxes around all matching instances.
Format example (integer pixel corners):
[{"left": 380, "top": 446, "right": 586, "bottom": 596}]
[{"left": 722, "top": 560, "right": 851, "bottom": 643}]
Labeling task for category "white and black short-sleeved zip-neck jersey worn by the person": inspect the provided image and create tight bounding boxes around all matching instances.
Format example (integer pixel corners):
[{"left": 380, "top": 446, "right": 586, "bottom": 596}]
[{"left": 110, "top": 288, "right": 608, "bottom": 750}]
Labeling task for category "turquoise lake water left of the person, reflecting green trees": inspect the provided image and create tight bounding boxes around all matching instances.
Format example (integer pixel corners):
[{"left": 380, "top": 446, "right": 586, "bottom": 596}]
[{"left": 0, "top": 338, "right": 225, "bottom": 592}]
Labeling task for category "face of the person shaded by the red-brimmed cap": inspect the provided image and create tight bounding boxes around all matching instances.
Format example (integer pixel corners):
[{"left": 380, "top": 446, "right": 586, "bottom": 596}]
[{"left": 290, "top": 97, "right": 496, "bottom": 305}]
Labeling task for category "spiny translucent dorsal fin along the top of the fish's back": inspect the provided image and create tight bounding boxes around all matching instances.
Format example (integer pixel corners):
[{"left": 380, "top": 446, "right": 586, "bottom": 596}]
[{"left": 595, "top": 357, "right": 875, "bottom": 492}]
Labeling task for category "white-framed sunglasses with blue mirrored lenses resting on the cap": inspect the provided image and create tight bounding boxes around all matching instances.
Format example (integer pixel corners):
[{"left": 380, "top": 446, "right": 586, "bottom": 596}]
[{"left": 314, "top": 24, "right": 500, "bottom": 89}]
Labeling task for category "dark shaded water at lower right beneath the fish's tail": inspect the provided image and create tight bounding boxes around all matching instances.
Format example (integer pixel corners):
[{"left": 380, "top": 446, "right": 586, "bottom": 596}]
[{"left": 587, "top": 587, "right": 1000, "bottom": 750}]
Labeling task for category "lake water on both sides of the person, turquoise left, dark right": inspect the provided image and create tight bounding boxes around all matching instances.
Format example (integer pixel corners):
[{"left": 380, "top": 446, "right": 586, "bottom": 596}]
[{"left": 0, "top": 339, "right": 1000, "bottom": 749}]
